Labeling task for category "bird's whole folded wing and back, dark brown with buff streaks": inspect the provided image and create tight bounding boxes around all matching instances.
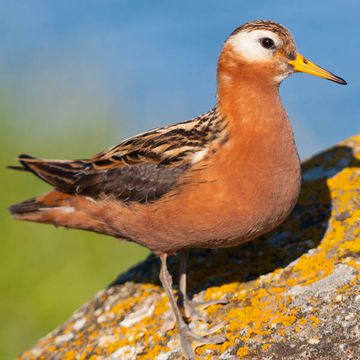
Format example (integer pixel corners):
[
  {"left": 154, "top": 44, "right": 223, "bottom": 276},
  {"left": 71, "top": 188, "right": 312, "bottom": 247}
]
[{"left": 10, "top": 110, "right": 228, "bottom": 203}]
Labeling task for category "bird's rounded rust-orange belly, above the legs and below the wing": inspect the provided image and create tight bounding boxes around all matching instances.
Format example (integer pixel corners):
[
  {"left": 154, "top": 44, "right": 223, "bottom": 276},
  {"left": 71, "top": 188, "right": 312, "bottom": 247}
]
[{"left": 107, "top": 154, "right": 300, "bottom": 253}]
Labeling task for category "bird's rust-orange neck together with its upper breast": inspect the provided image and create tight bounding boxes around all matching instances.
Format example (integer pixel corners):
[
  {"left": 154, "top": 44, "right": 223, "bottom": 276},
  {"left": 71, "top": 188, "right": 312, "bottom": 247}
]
[{"left": 217, "top": 49, "right": 299, "bottom": 172}]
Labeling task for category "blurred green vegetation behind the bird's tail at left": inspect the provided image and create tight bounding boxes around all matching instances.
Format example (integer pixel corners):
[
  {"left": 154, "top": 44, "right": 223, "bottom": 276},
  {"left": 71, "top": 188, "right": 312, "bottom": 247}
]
[{"left": 0, "top": 89, "right": 147, "bottom": 359}]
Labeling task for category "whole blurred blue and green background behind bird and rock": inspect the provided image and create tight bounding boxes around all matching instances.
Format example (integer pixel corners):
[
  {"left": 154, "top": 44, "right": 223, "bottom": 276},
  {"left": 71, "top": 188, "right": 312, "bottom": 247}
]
[{"left": 0, "top": 0, "right": 360, "bottom": 359}]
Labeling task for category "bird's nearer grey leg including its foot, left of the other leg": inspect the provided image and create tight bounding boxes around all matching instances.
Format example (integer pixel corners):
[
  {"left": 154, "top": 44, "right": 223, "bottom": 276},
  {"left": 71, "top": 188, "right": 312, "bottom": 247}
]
[{"left": 160, "top": 254, "right": 225, "bottom": 360}]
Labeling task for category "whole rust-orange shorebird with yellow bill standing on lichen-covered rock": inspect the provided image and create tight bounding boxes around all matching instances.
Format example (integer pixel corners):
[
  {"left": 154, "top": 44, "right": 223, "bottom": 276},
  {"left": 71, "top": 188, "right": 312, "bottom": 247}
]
[{"left": 10, "top": 21, "right": 346, "bottom": 359}]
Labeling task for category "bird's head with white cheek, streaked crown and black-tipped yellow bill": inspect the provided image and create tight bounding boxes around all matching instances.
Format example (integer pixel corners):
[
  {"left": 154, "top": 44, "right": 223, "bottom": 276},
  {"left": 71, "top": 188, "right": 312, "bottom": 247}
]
[{"left": 219, "top": 20, "right": 346, "bottom": 85}]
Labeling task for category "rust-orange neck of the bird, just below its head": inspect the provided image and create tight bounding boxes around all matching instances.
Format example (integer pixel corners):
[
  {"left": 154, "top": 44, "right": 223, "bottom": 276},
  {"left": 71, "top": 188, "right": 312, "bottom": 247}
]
[{"left": 217, "top": 52, "right": 287, "bottom": 132}]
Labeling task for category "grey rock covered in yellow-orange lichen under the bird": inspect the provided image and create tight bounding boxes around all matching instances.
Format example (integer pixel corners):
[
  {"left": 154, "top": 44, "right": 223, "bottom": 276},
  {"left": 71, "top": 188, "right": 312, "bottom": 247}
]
[{"left": 20, "top": 136, "right": 360, "bottom": 360}]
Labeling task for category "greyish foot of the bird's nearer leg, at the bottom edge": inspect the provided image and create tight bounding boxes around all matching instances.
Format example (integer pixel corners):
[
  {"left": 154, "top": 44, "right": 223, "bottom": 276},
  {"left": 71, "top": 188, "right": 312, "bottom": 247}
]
[{"left": 180, "top": 323, "right": 226, "bottom": 360}]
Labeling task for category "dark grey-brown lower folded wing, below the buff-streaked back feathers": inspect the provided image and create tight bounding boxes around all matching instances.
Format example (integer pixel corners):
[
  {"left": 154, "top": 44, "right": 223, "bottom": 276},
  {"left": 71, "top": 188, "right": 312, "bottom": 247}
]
[{"left": 11, "top": 155, "right": 187, "bottom": 203}]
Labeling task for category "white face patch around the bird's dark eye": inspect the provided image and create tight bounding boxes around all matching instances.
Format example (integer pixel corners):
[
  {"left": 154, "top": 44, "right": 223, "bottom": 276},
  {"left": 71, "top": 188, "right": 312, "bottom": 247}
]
[{"left": 227, "top": 30, "right": 283, "bottom": 62}]
